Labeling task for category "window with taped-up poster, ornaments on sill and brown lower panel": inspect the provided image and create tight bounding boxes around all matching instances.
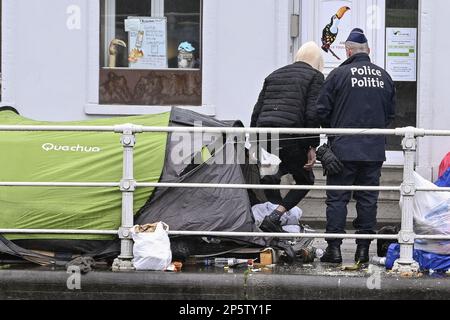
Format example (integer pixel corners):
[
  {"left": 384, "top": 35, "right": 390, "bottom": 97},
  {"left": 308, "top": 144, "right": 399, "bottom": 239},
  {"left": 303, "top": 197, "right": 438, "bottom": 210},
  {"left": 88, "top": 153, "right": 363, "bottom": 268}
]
[{"left": 99, "top": 0, "right": 202, "bottom": 106}]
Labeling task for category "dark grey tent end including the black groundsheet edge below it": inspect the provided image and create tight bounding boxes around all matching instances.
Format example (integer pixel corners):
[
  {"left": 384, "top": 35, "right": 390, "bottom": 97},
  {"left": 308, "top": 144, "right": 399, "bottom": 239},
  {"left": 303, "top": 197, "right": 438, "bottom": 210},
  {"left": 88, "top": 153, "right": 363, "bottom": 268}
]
[{"left": 136, "top": 109, "right": 267, "bottom": 256}]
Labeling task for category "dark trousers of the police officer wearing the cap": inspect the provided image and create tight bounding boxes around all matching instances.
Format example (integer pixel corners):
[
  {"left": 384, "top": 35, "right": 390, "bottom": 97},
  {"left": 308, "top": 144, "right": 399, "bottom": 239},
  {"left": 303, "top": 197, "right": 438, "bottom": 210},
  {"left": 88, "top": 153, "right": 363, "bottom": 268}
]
[{"left": 327, "top": 162, "right": 383, "bottom": 245}]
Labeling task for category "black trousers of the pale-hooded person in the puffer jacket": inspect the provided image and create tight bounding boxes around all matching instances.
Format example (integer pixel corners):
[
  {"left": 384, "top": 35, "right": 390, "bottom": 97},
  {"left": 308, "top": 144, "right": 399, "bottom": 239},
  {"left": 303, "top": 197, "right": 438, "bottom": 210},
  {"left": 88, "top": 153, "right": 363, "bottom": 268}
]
[{"left": 261, "top": 142, "right": 315, "bottom": 211}]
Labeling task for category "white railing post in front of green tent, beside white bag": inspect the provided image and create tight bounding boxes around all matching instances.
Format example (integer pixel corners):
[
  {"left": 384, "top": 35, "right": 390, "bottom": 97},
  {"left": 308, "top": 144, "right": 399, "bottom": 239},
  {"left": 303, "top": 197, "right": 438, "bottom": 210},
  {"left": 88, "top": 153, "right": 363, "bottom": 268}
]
[{"left": 113, "top": 125, "right": 136, "bottom": 271}]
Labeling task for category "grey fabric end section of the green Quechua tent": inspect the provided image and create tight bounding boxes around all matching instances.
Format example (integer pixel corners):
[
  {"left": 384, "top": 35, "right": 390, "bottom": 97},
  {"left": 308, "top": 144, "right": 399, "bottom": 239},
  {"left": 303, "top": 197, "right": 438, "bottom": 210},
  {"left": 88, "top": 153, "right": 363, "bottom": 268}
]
[{"left": 137, "top": 109, "right": 255, "bottom": 232}]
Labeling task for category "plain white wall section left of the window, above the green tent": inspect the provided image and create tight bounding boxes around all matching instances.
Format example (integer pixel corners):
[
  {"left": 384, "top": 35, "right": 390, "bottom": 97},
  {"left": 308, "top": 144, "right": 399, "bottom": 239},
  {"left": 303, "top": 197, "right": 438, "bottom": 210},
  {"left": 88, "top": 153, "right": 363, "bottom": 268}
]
[{"left": 3, "top": 0, "right": 88, "bottom": 120}]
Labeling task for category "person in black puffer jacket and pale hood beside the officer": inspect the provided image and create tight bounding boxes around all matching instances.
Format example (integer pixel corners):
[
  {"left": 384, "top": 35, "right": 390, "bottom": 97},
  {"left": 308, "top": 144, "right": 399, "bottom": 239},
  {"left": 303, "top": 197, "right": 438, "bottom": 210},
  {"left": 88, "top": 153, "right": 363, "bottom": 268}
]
[{"left": 251, "top": 42, "right": 324, "bottom": 232}]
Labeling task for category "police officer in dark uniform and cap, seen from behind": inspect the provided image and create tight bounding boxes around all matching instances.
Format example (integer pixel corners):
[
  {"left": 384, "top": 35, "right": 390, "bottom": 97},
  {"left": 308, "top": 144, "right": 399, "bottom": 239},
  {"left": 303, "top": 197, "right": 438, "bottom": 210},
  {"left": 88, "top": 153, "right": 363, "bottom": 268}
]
[{"left": 317, "top": 29, "right": 395, "bottom": 263}]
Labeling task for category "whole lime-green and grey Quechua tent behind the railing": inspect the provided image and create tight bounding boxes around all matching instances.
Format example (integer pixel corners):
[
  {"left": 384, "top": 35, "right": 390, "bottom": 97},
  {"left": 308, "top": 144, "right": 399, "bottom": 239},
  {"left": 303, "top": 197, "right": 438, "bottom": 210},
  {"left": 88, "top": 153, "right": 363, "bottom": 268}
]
[{"left": 0, "top": 108, "right": 258, "bottom": 262}]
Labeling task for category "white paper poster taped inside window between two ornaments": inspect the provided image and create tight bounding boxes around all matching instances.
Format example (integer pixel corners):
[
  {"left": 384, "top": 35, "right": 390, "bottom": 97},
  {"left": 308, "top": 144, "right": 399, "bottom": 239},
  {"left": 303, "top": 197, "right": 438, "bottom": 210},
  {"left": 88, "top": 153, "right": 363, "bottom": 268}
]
[{"left": 125, "top": 17, "right": 168, "bottom": 69}]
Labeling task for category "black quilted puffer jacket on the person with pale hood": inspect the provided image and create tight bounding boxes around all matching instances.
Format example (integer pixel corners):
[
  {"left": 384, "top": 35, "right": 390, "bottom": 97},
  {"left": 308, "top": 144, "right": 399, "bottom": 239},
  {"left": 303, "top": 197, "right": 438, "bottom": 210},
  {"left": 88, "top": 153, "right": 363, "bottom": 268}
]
[{"left": 251, "top": 62, "right": 324, "bottom": 148}]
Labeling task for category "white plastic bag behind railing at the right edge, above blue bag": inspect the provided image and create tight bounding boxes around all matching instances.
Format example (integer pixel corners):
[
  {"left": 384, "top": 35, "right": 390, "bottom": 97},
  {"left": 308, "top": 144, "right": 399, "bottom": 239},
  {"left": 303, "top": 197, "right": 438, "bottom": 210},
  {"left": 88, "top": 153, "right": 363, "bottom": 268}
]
[{"left": 401, "top": 173, "right": 450, "bottom": 255}]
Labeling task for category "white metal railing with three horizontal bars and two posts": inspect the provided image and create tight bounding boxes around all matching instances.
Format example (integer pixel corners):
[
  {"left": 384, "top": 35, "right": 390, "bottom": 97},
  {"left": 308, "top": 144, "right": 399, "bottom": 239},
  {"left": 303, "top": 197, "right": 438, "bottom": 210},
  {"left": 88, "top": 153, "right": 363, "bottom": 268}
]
[{"left": 0, "top": 124, "right": 450, "bottom": 272}]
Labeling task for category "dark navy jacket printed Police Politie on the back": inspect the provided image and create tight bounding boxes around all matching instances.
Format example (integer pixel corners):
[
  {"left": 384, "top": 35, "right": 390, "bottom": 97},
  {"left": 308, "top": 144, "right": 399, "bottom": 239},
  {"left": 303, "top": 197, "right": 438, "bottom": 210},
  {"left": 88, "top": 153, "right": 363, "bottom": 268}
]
[{"left": 317, "top": 53, "right": 395, "bottom": 162}]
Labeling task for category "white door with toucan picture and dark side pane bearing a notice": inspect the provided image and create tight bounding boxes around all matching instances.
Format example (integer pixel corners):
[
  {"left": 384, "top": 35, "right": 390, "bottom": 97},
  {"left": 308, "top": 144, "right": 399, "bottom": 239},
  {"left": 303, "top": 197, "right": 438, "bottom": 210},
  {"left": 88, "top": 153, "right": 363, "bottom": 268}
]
[{"left": 291, "top": 0, "right": 418, "bottom": 165}]
